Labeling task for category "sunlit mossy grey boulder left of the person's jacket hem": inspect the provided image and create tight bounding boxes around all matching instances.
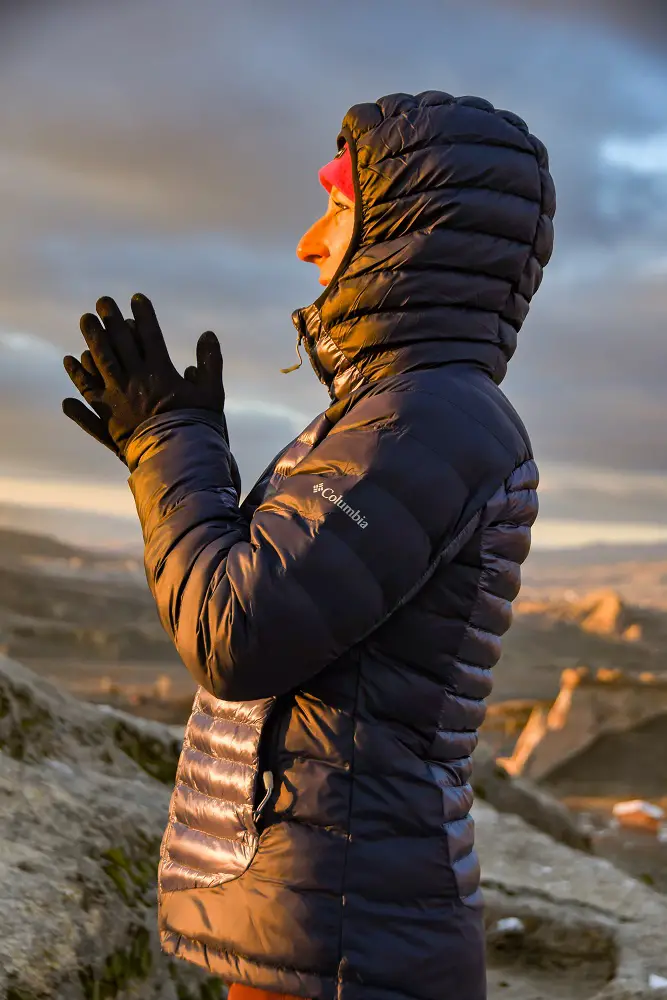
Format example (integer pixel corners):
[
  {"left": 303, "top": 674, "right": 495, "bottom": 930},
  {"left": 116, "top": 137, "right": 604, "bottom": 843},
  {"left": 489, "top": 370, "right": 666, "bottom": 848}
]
[{"left": 0, "top": 659, "right": 225, "bottom": 1000}]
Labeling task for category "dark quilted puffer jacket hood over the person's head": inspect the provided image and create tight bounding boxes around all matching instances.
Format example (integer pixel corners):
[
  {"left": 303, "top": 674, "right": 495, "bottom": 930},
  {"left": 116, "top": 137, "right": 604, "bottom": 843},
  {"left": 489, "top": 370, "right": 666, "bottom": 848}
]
[{"left": 286, "top": 90, "right": 556, "bottom": 400}]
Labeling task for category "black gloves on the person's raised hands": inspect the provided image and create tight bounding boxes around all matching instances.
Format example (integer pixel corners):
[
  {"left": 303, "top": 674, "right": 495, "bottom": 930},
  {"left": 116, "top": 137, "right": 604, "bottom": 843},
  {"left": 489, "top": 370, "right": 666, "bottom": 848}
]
[{"left": 63, "top": 295, "right": 230, "bottom": 460}]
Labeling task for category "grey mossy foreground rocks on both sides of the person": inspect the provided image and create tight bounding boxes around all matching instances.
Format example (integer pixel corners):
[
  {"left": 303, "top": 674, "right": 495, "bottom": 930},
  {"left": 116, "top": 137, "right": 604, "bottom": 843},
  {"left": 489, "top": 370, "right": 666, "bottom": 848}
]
[{"left": 0, "top": 658, "right": 667, "bottom": 1000}]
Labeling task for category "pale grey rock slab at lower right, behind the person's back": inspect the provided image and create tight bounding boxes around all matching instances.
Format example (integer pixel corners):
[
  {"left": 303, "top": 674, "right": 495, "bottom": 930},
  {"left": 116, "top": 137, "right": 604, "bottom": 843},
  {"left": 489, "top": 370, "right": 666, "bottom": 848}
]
[{"left": 473, "top": 802, "right": 667, "bottom": 1000}]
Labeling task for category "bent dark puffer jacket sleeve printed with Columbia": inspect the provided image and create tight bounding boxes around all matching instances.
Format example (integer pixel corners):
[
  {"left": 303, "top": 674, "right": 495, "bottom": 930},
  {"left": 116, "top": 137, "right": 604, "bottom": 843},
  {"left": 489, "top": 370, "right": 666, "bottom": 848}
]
[{"left": 127, "top": 396, "right": 469, "bottom": 701}]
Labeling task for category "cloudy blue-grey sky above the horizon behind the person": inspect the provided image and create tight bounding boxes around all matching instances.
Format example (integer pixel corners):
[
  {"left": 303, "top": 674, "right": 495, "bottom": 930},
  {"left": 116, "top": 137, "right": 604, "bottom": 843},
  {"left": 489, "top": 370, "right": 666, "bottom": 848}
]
[{"left": 0, "top": 0, "right": 667, "bottom": 548}]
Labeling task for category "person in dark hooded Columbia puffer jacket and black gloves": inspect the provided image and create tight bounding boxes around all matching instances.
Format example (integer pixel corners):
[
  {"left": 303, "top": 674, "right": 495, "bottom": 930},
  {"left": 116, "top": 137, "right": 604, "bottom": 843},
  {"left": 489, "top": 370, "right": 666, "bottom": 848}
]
[{"left": 63, "top": 91, "right": 555, "bottom": 1000}]
